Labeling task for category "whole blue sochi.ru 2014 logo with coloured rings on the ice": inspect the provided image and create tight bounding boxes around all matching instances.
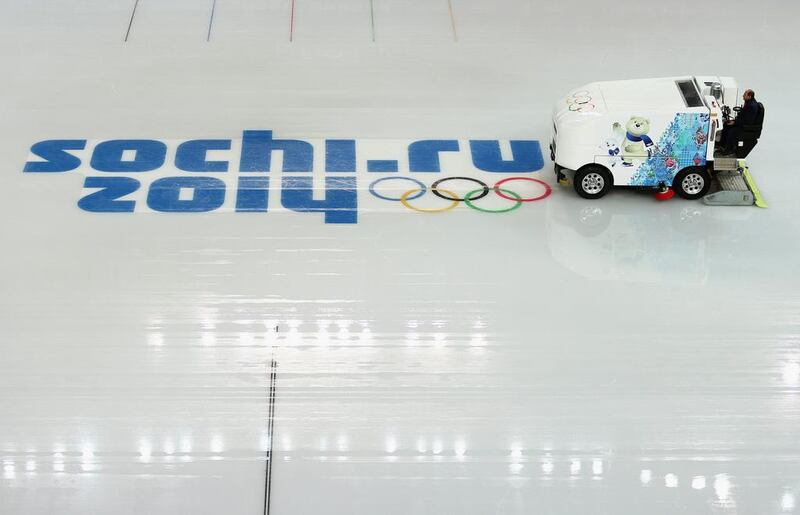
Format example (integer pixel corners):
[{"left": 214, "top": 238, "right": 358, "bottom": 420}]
[{"left": 24, "top": 130, "right": 550, "bottom": 224}]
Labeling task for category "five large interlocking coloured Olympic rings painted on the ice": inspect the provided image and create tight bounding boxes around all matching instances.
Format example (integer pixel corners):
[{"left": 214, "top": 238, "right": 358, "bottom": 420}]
[{"left": 369, "top": 176, "right": 553, "bottom": 213}]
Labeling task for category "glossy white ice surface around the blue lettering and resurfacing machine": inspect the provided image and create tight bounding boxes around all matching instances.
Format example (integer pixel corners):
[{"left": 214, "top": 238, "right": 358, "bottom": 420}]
[{"left": 0, "top": 0, "right": 800, "bottom": 515}]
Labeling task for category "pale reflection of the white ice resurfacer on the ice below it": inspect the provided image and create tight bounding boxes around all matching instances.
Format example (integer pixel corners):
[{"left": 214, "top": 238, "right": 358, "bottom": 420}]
[{"left": 547, "top": 194, "right": 752, "bottom": 284}]
